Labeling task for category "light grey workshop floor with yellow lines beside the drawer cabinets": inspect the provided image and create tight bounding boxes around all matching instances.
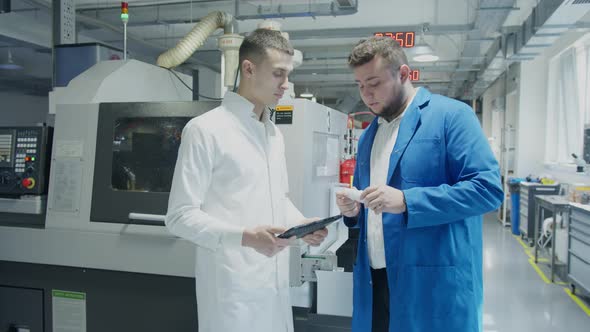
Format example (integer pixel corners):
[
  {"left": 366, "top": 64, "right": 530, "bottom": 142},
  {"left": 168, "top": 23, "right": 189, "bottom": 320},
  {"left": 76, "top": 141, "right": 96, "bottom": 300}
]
[{"left": 483, "top": 214, "right": 590, "bottom": 332}]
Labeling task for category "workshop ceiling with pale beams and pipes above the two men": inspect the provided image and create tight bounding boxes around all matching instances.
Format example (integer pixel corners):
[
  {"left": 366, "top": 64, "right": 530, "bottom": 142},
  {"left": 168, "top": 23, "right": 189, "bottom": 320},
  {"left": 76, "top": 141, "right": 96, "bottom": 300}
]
[{"left": 0, "top": 0, "right": 590, "bottom": 111}]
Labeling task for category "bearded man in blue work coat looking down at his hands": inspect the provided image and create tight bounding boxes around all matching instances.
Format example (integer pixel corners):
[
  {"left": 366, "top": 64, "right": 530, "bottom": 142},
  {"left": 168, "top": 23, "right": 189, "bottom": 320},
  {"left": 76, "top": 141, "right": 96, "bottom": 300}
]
[{"left": 337, "top": 37, "right": 503, "bottom": 332}]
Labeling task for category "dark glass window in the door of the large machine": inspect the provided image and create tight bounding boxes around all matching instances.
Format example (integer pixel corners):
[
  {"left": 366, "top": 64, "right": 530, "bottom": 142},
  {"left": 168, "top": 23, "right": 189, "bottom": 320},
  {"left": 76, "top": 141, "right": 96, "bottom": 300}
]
[{"left": 111, "top": 117, "right": 191, "bottom": 192}]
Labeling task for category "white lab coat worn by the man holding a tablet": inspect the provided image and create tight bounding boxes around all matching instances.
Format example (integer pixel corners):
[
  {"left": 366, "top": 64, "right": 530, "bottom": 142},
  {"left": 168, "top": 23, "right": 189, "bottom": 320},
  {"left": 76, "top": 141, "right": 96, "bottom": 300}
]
[{"left": 166, "top": 92, "right": 303, "bottom": 332}]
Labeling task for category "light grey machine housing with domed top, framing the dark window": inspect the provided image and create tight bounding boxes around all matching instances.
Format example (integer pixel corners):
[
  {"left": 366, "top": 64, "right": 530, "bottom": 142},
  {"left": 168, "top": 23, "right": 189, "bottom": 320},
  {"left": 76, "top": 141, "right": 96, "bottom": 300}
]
[{"left": 0, "top": 60, "right": 199, "bottom": 277}]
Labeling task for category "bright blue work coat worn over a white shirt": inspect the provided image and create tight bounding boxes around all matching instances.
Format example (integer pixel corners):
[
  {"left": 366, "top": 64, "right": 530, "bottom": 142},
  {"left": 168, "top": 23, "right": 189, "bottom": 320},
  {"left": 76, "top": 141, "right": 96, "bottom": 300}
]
[{"left": 344, "top": 88, "right": 503, "bottom": 332}]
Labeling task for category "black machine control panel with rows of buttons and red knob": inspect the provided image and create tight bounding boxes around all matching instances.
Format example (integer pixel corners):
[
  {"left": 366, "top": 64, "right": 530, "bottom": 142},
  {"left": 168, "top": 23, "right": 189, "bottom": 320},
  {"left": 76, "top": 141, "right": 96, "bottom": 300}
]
[{"left": 0, "top": 126, "right": 53, "bottom": 195}]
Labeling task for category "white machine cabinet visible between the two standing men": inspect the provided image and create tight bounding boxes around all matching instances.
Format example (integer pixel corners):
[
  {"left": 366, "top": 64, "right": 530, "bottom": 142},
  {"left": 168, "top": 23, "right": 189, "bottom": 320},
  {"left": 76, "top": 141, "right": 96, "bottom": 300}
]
[{"left": 277, "top": 98, "right": 348, "bottom": 254}]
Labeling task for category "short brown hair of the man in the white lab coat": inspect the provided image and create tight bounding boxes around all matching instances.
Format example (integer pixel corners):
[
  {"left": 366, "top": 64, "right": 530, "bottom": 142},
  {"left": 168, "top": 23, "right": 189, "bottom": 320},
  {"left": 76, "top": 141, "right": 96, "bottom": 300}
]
[{"left": 239, "top": 29, "right": 293, "bottom": 66}]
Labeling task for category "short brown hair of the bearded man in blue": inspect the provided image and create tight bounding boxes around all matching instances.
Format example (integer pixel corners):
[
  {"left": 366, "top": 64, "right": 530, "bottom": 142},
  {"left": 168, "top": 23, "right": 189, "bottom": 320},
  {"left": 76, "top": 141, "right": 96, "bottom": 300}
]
[{"left": 348, "top": 37, "right": 408, "bottom": 71}]
